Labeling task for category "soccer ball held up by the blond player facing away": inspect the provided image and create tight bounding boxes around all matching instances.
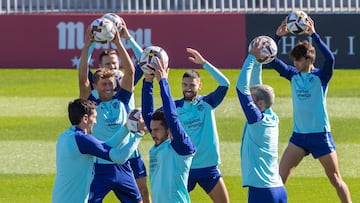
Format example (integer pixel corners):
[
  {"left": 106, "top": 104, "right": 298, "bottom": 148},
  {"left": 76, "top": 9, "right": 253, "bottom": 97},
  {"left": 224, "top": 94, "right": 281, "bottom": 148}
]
[{"left": 248, "top": 35, "right": 277, "bottom": 64}]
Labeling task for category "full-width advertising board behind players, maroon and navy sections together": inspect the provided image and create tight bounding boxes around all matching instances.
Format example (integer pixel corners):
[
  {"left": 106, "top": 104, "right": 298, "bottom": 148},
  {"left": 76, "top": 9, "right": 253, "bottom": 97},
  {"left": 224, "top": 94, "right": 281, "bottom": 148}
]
[{"left": 0, "top": 13, "right": 360, "bottom": 68}]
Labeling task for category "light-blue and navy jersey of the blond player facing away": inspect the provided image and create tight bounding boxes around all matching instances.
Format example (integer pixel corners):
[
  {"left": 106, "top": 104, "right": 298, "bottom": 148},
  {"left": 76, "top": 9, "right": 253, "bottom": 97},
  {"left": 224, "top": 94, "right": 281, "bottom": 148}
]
[{"left": 236, "top": 55, "right": 283, "bottom": 188}]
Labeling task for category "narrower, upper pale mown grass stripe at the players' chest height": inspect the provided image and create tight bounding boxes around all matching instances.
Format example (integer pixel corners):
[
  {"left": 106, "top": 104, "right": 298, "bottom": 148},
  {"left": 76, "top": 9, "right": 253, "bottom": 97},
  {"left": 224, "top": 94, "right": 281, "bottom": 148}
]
[{"left": 0, "top": 97, "right": 360, "bottom": 118}]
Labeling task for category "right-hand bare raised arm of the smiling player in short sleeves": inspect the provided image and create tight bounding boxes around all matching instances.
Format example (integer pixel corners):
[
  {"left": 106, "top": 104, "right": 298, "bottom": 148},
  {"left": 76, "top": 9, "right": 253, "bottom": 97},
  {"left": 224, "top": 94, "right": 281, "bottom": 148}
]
[{"left": 112, "top": 29, "right": 135, "bottom": 92}]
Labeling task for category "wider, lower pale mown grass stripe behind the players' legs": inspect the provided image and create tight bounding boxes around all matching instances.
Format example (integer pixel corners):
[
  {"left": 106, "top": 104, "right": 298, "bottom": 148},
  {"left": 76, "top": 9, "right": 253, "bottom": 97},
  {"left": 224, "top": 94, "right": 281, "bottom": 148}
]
[{"left": 0, "top": 140, "right": 360, "bottom": 177}]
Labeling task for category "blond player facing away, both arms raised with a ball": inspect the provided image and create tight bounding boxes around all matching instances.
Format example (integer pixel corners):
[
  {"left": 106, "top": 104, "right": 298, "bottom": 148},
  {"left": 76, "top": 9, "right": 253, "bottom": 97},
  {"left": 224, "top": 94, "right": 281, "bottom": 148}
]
[{"left": 236, "top": 41, "right": 287, "bottom": 203}]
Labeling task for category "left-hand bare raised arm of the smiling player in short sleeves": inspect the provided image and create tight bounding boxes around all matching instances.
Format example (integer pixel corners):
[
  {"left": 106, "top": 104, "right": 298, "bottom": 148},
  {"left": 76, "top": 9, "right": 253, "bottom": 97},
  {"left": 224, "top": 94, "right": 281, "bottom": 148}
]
[{"left": 78, "top": 26, "right": 94, "bottom": 99}]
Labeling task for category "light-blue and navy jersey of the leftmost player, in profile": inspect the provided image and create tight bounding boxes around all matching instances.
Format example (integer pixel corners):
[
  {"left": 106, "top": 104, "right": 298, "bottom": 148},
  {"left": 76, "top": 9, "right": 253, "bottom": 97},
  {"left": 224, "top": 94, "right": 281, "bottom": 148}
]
[{"left": 52, "top": 126, "right": 141, "bottom": 203}]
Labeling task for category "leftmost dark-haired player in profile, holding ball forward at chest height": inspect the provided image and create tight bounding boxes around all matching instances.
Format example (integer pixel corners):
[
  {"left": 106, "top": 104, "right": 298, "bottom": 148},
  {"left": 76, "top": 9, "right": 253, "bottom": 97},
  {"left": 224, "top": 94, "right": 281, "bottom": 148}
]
[{"left": 52, "top": 99, "right": 146, "bottom": 203}]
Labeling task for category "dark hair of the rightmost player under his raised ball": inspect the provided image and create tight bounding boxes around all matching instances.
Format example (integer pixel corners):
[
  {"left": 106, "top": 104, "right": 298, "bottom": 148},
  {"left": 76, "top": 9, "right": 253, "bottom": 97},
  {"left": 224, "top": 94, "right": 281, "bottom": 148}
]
[{"left": 290, "top": 40, "right": 316, "bottom": 63}]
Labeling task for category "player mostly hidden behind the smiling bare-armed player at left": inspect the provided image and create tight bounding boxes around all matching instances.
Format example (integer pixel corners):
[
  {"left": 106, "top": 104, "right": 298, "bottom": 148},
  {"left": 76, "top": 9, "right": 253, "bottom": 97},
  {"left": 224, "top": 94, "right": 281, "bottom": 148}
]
[{"left": 88, "top": 20, "right": 151, "bottom": 203}]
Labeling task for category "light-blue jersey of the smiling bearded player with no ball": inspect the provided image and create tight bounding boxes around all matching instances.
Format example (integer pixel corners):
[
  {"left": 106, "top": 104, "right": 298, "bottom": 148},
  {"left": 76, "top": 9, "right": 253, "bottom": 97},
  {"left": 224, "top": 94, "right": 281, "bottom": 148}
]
[{"left": 175, "top": 62, "right": 230, "bottom": 169}]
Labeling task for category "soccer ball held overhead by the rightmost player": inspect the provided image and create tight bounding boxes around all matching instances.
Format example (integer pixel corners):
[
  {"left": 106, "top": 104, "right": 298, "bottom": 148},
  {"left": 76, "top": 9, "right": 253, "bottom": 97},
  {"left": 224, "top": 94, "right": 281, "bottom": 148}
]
[{"left": 286, "top": 11, "right": 308, "bottom": 35}]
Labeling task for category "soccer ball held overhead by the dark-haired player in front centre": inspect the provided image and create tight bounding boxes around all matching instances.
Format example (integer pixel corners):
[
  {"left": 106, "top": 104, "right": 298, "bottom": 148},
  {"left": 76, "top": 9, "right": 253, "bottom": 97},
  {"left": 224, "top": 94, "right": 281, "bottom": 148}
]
[{"left": 139, "top": 46, "right": 169, "bottom": 74}]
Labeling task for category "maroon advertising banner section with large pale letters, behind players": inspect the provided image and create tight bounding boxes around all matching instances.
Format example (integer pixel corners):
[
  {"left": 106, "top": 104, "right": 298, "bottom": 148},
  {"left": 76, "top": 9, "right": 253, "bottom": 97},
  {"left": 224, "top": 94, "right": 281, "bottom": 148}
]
[{"left": 0, "top": 14, "right": 246, "bottom": 68}]
